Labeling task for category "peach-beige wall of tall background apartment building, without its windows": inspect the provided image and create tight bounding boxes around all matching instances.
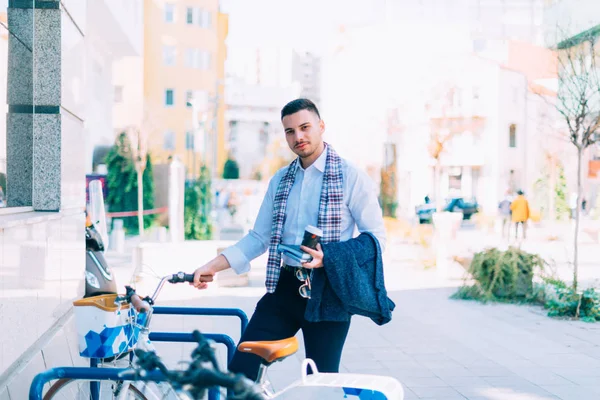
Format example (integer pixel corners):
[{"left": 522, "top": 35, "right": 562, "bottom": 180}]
[{"left": 144, "top": 0, "right": 227, "bottom": 175}]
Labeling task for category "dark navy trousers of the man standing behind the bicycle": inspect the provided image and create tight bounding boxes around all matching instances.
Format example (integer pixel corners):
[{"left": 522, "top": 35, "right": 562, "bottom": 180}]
[{"left": 229, "top": 269, "right": 350, "bottom": 380}]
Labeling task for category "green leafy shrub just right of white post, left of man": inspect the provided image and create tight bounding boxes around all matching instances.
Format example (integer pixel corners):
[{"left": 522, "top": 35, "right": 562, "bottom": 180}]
[{"left": 184, "top": 165, "right": 213, "bottom": 240}]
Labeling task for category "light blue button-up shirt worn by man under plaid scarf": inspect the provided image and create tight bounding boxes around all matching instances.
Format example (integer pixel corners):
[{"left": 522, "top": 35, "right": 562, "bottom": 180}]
[{"left": 221, "top": 150, "right": 386, "bottom": 274}]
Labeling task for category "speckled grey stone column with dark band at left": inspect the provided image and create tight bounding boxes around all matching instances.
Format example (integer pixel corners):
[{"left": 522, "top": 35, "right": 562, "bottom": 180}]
[{"left": 6, "top": 0, "right": 61, "bottom": 211}]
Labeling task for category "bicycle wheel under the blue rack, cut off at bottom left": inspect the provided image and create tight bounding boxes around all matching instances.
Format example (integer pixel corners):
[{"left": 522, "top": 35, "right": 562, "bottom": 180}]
[{"left": 44, "top": 378, "right": 148, "bottom": 400}]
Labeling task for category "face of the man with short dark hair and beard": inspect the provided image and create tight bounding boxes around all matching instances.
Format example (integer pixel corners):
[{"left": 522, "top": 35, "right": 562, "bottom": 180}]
[{"left": 282, "top": 110, "right": 325, "bottom": 158}]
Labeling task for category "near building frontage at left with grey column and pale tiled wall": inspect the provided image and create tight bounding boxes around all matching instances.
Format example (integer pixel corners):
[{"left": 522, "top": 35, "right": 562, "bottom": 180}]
[{"left": 0, "top": 0, "right": 149, "bottom": 399}]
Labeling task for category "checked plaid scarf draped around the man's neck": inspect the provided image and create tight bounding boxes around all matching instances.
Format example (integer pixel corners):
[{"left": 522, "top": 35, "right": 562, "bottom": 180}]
[{"left": 265, "top": 143, "right": 344, "bottom": 293}]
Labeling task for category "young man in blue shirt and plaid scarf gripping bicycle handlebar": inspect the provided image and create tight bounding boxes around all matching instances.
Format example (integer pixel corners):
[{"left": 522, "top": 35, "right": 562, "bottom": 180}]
[{"left": 194, "top": 99, "right": 385, "bottom": 380}]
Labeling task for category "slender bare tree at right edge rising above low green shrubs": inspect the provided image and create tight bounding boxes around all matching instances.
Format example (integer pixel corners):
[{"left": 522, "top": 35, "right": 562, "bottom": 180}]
[{"left": 556, "top": 28, "right": 600, "bottom": 291}]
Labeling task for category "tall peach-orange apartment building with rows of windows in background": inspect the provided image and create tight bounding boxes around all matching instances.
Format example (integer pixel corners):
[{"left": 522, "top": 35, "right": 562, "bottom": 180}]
[{"left": 141, "top": 0, "right": 228, "bottom": 177}]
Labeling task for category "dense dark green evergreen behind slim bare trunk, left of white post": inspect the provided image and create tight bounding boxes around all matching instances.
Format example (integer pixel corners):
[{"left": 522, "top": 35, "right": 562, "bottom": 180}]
[{"left": 106, "top": 132, "right": 155, "bottom": 234}]
